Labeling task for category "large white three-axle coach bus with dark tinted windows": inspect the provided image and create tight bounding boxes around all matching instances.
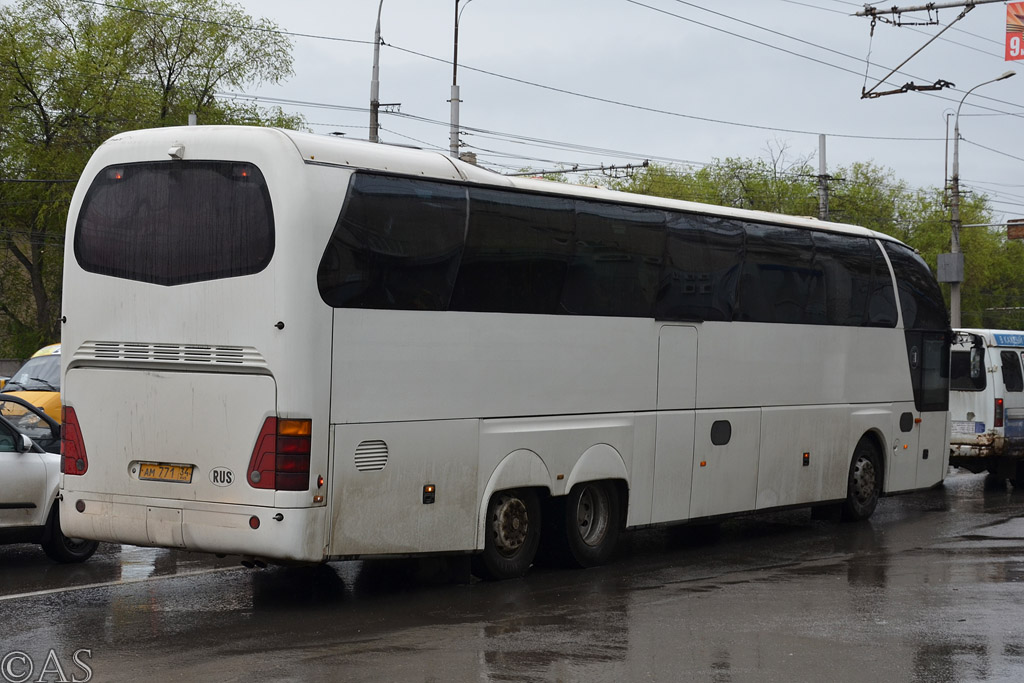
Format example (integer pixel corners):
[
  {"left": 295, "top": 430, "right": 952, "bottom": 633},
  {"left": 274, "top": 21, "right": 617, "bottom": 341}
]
[{"left": 60, "top": 127, "right": 950, "bottom": 579}]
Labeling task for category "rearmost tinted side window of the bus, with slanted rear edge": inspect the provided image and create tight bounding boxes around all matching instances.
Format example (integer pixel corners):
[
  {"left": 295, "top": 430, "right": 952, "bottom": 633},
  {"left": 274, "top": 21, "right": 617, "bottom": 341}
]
[{"left": 316, "top": 173, "right": 467, "bottom": 310}]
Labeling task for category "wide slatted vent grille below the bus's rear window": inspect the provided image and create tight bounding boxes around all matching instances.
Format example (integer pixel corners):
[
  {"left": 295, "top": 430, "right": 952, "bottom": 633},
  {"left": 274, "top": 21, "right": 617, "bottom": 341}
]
[{"left": 72, "top": 341, "right": 266, "bottom": 369}]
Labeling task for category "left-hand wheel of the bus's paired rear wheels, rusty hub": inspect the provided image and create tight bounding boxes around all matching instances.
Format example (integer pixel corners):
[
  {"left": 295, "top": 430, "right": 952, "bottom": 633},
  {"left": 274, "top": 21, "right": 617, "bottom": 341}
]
[{"left": 472, "top": 488, "right": 541, "bottom": 581}]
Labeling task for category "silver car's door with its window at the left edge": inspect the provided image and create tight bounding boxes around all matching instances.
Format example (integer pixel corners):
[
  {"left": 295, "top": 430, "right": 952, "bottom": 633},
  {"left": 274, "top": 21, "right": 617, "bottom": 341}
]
[{"left": 0, "top": 418, "right": 48, "bottom": 530}]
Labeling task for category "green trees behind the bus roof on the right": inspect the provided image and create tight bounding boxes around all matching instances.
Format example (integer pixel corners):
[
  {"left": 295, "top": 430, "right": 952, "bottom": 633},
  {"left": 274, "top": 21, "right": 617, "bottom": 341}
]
[{"left": 606, "top": 154, "right": 1024, "bottom": 330}]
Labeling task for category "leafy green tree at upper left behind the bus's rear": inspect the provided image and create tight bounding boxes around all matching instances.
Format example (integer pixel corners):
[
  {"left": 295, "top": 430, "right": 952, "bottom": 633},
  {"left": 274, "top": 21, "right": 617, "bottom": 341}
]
[{"left": 0, "top": 0, "right": 303, "bottom": 357}]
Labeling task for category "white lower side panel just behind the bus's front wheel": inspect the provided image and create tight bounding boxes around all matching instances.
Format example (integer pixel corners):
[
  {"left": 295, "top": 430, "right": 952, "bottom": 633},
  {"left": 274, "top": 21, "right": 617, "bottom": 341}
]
[{"left": 757, "top": 405, "right": 856, "bottom": 510}]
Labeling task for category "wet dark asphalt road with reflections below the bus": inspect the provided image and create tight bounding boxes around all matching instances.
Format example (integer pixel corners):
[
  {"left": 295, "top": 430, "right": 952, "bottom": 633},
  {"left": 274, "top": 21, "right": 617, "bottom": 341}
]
[{"left": 0, "top": 474, "right": 1024, "bottom": 683}]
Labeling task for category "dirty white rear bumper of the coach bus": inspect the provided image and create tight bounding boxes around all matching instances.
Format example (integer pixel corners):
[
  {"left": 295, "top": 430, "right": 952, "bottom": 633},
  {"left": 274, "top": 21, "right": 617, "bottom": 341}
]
[{"left": 60, "top": 489, "right": 326, "bottom": 563}]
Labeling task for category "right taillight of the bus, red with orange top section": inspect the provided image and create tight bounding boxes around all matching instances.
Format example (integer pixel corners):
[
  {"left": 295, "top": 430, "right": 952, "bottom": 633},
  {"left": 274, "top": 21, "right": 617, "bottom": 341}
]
[{"left": 246, "top": 418, "right": 312, "bottom": 490}]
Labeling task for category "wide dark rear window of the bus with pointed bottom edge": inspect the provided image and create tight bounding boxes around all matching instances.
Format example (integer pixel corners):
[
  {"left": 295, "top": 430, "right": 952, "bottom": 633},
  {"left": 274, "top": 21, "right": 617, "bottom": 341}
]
[{"left": 75, "top": 161, "right": 273, "bottom": 286}]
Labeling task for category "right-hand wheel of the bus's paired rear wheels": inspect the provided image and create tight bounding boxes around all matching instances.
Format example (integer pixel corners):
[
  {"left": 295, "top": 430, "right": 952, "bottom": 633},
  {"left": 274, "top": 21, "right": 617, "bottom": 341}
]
[{"left": 560, "top": 481, "right": 622, "bottom": 567}]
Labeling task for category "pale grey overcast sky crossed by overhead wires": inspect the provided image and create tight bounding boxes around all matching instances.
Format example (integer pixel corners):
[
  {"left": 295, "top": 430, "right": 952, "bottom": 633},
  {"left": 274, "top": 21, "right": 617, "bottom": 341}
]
[{"left": 114, "top": 0, "right": 1024, "bottom": 222}]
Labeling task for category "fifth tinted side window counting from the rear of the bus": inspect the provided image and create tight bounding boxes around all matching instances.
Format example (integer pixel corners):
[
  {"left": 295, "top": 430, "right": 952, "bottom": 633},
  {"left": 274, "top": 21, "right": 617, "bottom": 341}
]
[{"left": 736, "top": 223, "right": 827, "bottom": 325}]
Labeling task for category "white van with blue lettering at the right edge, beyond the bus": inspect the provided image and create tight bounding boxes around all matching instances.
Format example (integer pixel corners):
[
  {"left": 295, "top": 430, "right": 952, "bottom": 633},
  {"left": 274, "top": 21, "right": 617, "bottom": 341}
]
[{"left": 949, "top": 329, "right": 1024, "bottom": 484}]
